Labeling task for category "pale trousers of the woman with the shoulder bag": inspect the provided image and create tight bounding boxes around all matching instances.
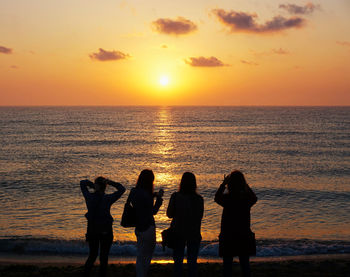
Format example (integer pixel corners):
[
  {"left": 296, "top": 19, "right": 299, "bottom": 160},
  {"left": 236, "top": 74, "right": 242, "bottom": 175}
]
[{"left": 135, "top": 225, "right": 156, "bottom": 277}]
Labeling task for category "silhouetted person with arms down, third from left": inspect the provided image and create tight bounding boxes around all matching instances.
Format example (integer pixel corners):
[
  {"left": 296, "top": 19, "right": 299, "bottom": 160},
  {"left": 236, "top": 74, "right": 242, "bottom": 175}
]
[{"left": 167, "top": 172, "right": 204, "bottom": 277}]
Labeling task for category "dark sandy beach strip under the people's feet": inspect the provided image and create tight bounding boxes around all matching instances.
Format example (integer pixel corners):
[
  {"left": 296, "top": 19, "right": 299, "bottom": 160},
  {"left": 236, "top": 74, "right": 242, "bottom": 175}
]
[{"left": 0, "top": 254, "right": 350, "bottom": 277}]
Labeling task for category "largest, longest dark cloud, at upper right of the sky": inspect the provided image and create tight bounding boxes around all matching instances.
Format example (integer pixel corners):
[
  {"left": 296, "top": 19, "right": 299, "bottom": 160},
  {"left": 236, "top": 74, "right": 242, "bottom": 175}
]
[{"left": 212, "top": 9, "right": 305, "bottom": 33}]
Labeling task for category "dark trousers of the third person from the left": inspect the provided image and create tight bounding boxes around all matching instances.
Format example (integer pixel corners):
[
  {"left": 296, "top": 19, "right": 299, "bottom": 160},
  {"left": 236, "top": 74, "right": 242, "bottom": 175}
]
[{"left": 173, "top": 237, "right": 200, "bottom": 277}]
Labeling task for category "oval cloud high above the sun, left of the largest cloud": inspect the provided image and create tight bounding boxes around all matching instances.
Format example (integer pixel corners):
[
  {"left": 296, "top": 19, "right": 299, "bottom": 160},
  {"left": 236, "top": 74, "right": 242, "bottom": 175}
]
[{"left": 152, "top": 17, "right": 198, "bottom": 36}]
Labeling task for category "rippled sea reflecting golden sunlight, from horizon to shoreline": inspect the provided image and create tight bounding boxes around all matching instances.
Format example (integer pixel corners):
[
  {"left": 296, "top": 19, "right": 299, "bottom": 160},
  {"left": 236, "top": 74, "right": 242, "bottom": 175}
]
[{"left": 0, "top": 107, "right": 350, "bottom": 256}]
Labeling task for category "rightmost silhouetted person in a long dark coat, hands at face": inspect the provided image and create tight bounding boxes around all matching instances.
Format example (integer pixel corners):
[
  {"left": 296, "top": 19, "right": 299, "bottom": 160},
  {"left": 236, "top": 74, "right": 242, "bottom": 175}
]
[{"left": 215, "top": 170, "right": 258, "bottom": 277}]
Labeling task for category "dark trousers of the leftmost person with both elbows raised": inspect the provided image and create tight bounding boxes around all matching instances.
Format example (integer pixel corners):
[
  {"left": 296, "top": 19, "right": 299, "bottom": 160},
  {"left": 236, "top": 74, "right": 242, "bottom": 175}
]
[{"left": 84, "top": 232, "right": 113, "bottom": 277}]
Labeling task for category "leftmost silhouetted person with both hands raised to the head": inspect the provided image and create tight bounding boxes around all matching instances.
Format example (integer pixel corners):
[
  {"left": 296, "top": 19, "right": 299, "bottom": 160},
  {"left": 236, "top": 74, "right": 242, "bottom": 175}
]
[{"left": 80, "top": 177, "right": 125, "bottom": 277}]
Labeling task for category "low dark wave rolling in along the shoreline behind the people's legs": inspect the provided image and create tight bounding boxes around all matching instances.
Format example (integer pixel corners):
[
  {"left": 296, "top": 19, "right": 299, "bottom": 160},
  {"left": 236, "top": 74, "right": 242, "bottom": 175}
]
[{"left": 0, "top": 238, "right": 350, "bottom": 257}]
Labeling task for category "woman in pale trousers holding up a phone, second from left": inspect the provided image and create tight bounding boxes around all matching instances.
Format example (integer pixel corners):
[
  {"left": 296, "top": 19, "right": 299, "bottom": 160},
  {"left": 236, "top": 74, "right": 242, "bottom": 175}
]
[{"left": 129, "top": 169, "right": 164, "bottom": 277}]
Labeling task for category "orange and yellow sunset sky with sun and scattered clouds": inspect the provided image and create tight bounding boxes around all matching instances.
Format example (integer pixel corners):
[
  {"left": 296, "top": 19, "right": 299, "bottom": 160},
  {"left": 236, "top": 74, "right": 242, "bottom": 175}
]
[{"left": 0, "top": 0, "right": 350, "bottom": 106}]
